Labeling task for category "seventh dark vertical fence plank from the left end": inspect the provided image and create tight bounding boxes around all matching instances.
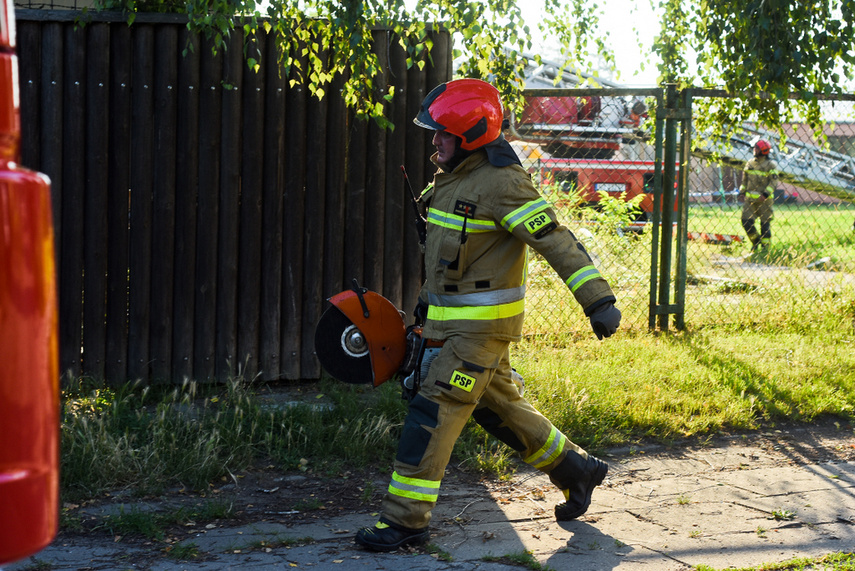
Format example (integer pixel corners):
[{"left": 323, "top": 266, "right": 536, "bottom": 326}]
[{"left": 149, "top": 24, "right": 181, "bottom": 383}]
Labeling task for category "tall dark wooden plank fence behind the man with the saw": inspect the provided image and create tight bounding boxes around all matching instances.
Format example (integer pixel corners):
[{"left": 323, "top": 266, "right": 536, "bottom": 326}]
[{"left": 17, "top": 10, "right": 451, "bottom": 385}]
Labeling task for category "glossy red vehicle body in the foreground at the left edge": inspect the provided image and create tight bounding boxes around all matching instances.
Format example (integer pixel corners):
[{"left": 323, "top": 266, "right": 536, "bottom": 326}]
[{"left": 0, "top": 0, "right": 59, "bottom": 565}]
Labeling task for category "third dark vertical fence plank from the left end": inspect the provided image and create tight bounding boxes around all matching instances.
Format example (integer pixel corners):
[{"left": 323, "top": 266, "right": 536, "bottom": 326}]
[{"left": 59, "top": 21, "right": 86, "bottom": 377}]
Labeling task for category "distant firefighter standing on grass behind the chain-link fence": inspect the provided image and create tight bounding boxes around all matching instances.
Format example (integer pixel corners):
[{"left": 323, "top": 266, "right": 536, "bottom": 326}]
[{"left": 738, "top": 139, "right": 778, "bottom": 253}]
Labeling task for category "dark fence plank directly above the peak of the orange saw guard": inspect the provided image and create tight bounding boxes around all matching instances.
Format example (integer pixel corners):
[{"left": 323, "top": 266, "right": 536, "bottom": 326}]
[{"left": 359, "top": 30, "right": 388, "bottom": 294}]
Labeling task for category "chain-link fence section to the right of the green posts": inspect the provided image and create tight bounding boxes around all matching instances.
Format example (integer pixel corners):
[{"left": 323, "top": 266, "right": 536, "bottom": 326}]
[{"left": 686, "top": 101, "right": 855, "bottom": 325}]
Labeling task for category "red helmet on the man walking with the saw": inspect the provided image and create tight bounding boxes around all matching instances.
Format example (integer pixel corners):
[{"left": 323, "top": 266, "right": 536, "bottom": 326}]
[{"left": 413, "top": 79, "right": 504, "bottom": 151}]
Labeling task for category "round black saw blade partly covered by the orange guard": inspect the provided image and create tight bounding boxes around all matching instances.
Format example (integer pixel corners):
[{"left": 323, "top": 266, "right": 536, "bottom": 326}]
[{"left": 315, "top": 306, "right": 374, "bottom": 383}]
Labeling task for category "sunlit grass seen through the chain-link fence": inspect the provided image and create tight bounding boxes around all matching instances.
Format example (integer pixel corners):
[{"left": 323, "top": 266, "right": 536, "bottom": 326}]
[{"left": 526, "top": 201, "right": 855, "bottom": 334}]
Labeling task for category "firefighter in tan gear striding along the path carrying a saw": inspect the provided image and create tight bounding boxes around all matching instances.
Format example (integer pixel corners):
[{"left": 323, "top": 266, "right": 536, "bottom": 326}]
[{"left": 356, "top": 79, "right": 621, "bottom": 551}]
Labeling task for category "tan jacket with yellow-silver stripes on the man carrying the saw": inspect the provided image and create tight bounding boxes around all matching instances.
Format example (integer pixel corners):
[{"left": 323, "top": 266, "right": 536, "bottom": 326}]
[{"left": 419, "top": 150, "right": 615, "bottom": 341}]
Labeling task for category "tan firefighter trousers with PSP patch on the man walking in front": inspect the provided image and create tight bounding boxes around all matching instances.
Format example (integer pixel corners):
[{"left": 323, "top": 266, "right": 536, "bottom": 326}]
[{"left": 382, "top": 336, "right": 588, "bottom": 529}]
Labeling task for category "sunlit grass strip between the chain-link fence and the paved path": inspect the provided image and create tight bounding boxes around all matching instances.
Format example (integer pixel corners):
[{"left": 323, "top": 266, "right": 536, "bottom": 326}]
[{"left": 512, "top": 330, "right": 855, "bottom": 447}]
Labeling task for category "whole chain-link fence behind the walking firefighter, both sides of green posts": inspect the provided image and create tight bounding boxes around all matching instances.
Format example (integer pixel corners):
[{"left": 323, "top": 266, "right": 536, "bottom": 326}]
[{"left": 511, "top": 90, "right": 855, "bottom": 334}]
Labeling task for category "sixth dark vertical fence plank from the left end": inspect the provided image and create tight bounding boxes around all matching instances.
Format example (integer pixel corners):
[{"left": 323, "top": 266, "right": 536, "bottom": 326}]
[{"left": 128, "top": 24, "right": 154, "bottom": 383}]
